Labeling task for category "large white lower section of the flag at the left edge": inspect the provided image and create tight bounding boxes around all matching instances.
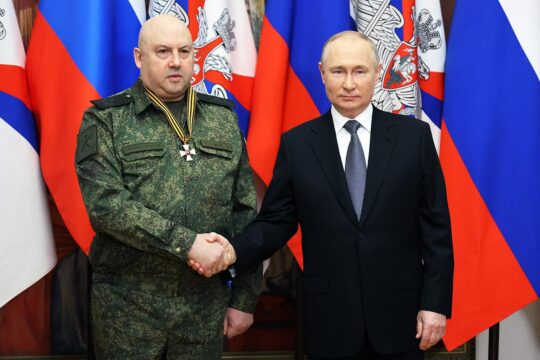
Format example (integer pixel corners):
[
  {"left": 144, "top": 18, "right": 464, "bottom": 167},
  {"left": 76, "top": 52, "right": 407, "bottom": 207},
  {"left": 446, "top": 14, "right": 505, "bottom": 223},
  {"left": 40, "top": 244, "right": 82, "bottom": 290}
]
[{"left": 0, "top": 118, "right": 56, "bottom": 307}]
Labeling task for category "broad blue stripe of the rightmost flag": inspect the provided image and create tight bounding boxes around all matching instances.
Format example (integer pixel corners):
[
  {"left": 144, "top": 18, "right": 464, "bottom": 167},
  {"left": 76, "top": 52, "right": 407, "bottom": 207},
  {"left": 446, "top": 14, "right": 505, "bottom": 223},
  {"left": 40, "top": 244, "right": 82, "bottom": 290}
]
[{"left": 444, "top": 0, "right": 540, "bottom": 293}]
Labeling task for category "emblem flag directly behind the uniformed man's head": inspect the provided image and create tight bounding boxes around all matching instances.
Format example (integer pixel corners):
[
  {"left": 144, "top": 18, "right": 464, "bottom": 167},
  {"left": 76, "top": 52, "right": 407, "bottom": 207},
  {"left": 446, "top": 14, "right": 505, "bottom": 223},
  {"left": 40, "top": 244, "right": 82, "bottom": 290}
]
[{"left": 148, "top": 0, "right": 257, "bottom": 136}]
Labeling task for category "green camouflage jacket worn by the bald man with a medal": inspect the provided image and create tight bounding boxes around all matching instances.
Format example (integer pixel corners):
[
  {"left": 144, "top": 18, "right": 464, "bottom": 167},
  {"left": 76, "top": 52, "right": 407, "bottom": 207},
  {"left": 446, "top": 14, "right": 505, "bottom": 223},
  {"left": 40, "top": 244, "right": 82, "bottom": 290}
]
[{"left": 76, "top": 81, "right": 262, "bottom": 312}]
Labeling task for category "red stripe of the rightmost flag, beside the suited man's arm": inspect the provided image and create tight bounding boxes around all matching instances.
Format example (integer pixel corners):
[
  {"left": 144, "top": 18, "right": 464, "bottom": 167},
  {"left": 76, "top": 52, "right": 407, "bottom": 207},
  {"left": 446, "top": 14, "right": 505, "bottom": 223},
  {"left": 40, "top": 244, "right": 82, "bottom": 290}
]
[{"left": 440, "top": 122, "right": 538, "bottom": 350}]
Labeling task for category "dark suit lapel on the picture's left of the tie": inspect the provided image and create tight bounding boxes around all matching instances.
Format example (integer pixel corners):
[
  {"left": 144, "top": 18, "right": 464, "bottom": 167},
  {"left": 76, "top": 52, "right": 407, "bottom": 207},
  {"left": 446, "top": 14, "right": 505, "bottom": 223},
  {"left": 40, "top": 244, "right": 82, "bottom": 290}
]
[{"left": 308, "top": 112, "right": 358, "bottom": 224}]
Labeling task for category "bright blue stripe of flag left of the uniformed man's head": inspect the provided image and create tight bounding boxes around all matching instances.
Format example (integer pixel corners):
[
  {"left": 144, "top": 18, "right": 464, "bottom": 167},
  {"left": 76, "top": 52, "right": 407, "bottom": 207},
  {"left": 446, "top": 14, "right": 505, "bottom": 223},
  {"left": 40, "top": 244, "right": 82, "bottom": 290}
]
[{"left": 39, "top": 0, "right": 141, "bottom": 97}]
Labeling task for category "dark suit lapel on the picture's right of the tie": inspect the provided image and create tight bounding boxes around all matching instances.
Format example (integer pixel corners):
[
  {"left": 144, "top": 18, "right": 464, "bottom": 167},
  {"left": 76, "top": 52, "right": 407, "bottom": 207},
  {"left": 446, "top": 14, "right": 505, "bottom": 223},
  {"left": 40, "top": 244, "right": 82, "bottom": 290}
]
[{"left": 360, "top": 107, "right": 396, "bottom": 226}]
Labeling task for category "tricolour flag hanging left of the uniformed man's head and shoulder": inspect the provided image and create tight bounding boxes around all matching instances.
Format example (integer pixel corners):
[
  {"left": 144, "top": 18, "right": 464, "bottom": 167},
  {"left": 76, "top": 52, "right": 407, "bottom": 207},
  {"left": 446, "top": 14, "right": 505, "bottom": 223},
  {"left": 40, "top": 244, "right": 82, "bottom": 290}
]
[{"left": 26, "top": 0, "right": 145, "bottom": 253}]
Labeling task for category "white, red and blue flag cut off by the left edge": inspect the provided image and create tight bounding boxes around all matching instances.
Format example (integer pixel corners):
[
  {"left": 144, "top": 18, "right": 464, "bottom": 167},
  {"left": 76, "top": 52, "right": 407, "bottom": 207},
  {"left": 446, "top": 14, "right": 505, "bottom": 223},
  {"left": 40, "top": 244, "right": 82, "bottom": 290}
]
[{"left": 0, "top": 0, "right": 56, "bottom": 307}]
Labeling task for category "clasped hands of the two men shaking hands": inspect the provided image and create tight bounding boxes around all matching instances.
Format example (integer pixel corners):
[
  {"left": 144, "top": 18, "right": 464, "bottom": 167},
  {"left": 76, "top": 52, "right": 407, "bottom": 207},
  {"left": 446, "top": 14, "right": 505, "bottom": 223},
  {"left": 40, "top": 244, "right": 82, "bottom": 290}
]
[{"left": 188, "top": 232, "right": 236, "bottom": 277}]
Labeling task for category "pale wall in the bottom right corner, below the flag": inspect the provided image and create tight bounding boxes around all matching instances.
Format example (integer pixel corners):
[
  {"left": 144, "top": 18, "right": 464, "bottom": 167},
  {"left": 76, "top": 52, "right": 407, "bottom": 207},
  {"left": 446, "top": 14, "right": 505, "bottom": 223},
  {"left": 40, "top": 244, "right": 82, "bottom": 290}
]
[{"left": 476, "top": 301, "right": 540, "bottom": 360}]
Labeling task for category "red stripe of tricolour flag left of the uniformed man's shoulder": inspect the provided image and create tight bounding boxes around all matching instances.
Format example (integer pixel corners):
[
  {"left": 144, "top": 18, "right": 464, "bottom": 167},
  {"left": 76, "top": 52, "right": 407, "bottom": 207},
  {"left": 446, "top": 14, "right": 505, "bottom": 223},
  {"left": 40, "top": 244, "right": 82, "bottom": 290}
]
[{"left": 26, "top": 11, "right": 99, "bottom": 253}]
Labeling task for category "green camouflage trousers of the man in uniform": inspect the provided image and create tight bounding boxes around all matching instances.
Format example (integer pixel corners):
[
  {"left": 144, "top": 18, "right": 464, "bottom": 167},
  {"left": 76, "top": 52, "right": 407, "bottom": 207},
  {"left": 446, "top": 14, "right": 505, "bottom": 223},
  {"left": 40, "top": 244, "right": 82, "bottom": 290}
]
[{"left": 91, "top": 283, "right": 230, "bottom": 360}]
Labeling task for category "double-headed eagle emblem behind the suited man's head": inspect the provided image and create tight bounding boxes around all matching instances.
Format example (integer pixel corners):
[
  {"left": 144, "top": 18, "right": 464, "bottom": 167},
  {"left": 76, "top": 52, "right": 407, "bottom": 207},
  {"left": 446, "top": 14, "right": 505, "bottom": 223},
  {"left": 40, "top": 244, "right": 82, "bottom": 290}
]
[{"left": 351, "top": 0, "right": 442, "bottom": 118}]
